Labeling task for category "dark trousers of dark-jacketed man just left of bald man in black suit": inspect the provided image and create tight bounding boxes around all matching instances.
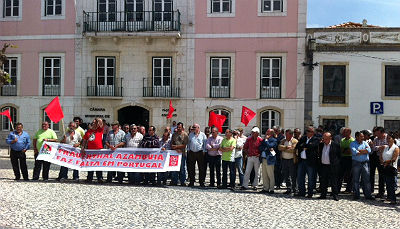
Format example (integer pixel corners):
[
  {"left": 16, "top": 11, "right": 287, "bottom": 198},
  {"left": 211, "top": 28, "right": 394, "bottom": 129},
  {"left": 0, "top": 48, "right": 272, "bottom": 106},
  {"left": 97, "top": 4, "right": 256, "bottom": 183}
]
[{"left": 297, "top": 160, "right": 316, "bottom": 195}]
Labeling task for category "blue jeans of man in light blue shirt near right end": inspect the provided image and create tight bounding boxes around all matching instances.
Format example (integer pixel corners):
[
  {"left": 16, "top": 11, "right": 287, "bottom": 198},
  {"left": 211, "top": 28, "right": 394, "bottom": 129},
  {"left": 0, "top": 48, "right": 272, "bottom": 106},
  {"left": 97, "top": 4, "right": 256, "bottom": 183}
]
[{"left": 352, "top": 160, "right": 371, "bottom": 198}]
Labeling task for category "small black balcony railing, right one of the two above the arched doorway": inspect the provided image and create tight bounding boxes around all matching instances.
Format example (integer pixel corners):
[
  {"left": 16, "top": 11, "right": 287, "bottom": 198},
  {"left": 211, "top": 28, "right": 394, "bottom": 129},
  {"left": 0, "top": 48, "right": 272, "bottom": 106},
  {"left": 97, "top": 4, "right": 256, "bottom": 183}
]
[{"left": 143, "top": 78, "right": 181, "bottom": 98}]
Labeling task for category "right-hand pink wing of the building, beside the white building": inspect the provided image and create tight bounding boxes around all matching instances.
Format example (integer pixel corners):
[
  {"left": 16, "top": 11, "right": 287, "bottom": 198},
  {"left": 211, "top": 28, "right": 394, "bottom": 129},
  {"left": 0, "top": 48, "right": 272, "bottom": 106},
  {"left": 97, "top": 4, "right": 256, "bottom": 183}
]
[{"left": 194, "top": 0, "right": 307, "bottom": 133}]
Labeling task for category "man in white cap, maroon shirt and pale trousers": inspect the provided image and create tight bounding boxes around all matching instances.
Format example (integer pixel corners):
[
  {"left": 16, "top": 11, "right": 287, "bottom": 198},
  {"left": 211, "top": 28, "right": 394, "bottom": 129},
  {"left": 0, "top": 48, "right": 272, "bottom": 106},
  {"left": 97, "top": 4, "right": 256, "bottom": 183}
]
[{"left": 242, "top": 127, "right": 263, "bottom": 189}]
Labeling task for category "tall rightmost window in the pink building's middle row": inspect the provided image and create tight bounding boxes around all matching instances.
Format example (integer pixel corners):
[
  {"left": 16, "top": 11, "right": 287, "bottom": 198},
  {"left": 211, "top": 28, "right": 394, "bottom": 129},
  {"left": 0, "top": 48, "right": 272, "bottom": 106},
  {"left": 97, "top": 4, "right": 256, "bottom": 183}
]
[{"left": 260, "top": 57, "right": 282, "bottom": 99}]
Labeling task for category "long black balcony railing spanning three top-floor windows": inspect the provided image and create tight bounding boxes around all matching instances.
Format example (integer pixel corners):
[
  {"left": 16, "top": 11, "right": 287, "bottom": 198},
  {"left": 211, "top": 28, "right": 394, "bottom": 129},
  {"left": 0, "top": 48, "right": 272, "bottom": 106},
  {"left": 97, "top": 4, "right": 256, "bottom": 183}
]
[{"left": 83, "top": 11, "right": 181, "bottom": 32}]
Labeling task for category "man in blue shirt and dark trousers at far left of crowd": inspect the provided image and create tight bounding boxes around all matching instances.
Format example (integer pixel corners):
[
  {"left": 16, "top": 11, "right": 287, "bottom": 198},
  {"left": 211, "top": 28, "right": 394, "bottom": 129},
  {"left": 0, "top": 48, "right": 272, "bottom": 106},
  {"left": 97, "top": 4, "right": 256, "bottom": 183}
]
[{"left": 6, "top": 123, "right": 31, "bottom": 180}]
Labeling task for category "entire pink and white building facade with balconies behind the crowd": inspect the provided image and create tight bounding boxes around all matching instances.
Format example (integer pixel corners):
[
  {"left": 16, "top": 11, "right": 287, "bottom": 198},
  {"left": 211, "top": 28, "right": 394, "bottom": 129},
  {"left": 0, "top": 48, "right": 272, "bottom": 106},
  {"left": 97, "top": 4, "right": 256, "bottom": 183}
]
[{"left": 0, "top": 0, "right": 307, "bottom": 147}]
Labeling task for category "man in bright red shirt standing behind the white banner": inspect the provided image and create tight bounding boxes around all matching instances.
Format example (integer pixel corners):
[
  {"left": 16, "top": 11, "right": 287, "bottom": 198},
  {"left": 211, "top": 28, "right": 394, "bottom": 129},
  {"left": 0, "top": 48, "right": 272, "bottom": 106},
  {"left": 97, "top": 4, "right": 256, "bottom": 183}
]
[{"left": 81, "top": 118, "right": 104, "bottom": 183}]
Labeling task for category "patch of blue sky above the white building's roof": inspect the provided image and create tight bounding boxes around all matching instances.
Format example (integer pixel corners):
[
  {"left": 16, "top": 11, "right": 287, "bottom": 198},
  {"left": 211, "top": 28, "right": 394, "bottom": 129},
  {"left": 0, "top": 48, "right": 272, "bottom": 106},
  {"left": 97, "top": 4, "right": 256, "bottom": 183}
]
[{"left": 307, "top": 0, "right": 400, "bottom": 28}]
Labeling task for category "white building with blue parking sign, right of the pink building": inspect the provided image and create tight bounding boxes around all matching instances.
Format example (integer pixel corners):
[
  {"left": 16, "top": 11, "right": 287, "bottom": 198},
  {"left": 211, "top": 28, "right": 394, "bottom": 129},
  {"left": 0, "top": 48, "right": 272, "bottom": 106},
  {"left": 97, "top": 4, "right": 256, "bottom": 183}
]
[{"left": 305, "top": 22, "right": 400, "bottom": 132}]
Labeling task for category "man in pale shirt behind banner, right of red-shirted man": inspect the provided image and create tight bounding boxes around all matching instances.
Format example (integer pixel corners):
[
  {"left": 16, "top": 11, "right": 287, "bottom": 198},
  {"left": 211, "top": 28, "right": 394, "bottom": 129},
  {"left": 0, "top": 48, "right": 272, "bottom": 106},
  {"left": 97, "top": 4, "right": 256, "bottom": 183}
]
[{"left": 106, "top": 121, "right": 125, "bottom": 184}]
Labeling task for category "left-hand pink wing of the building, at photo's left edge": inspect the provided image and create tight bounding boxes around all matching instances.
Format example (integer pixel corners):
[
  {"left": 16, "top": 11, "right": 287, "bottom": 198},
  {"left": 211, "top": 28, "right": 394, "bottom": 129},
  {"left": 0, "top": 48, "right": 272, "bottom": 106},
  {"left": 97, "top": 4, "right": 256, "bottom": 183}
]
[{"left": 0, "top": 0, "right": 76, "bottom": 139}]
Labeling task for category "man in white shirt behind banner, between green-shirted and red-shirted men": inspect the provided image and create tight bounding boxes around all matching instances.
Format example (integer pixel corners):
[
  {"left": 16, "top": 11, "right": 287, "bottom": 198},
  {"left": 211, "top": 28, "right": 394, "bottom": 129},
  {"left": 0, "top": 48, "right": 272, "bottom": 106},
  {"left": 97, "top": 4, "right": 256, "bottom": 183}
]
[{"left": 57, "top": 122, "right": 82, "bottom": 182}]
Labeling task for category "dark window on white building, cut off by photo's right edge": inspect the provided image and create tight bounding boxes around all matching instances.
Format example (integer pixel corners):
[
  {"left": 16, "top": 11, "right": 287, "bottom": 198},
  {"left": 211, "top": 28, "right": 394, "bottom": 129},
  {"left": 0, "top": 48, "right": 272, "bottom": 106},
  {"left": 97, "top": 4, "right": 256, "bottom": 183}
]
[{"left": 385, "top": 65, "right": 400, "bottom": 96}]
